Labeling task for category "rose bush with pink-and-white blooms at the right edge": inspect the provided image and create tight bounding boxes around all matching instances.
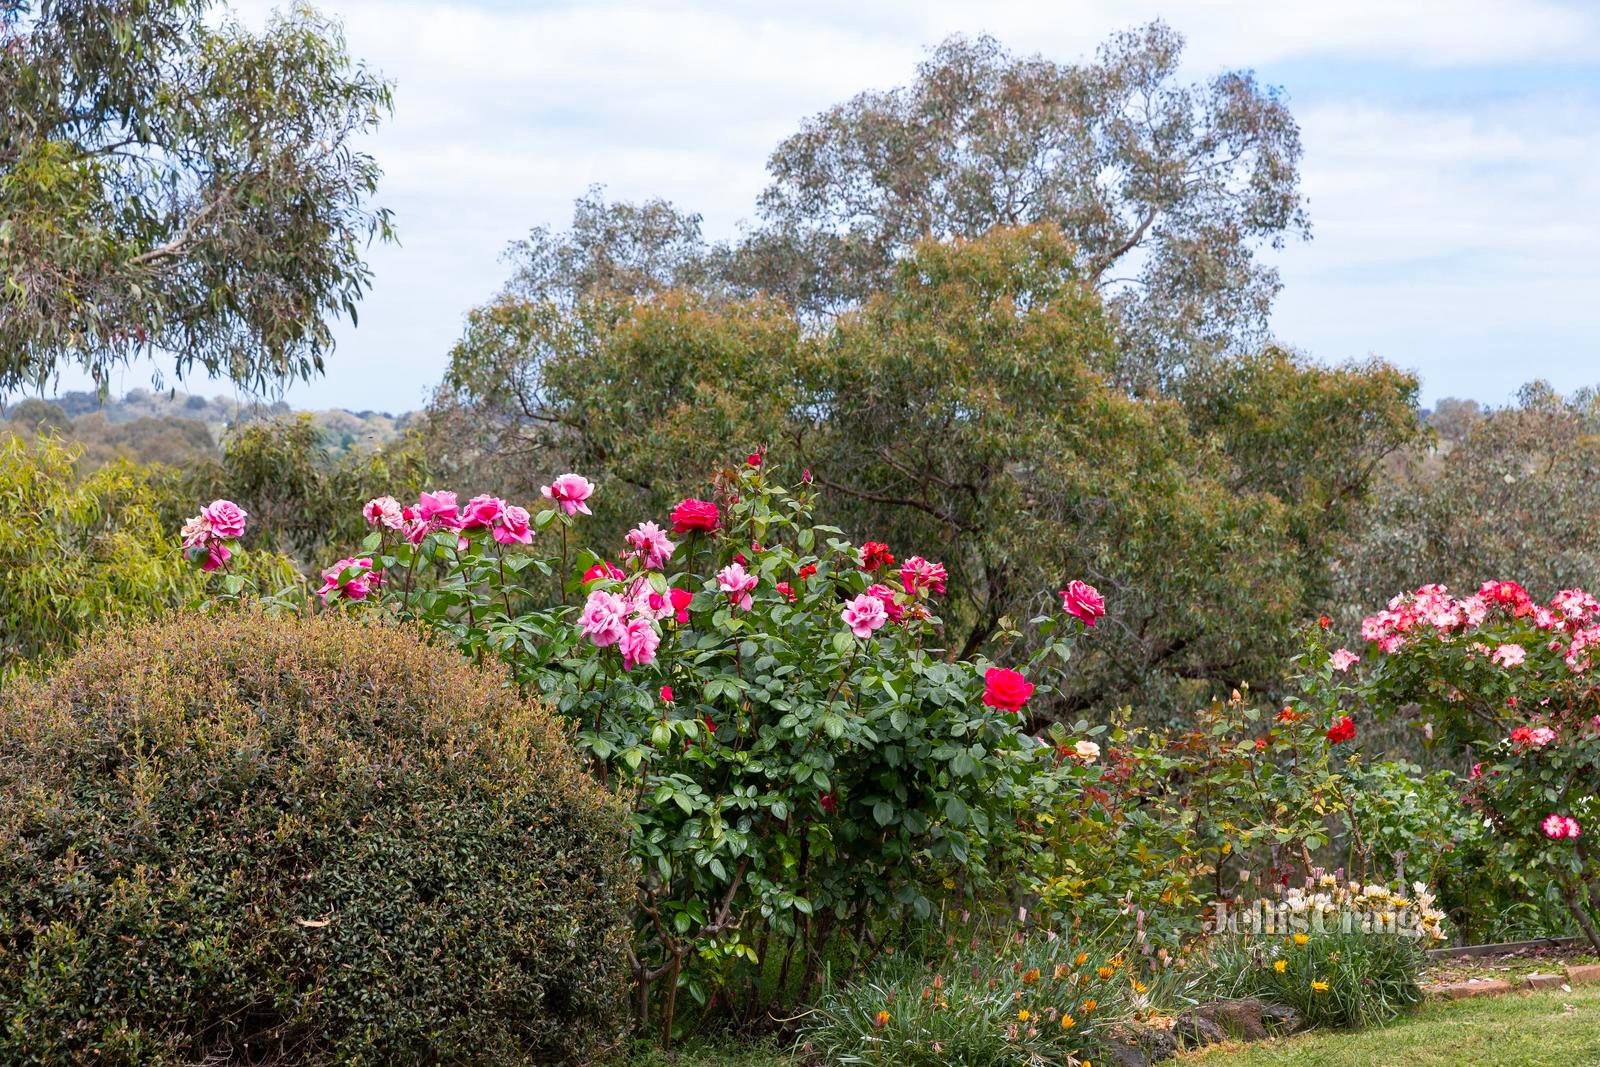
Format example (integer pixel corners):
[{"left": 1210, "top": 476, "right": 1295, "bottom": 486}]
[{"left": 1362, "top": 581, "right": 1600, "bottom": 952}]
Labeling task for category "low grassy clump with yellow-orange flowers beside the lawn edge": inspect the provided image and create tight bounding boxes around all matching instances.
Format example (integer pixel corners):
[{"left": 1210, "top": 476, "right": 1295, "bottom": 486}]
[{"left": 1198, "top": 929, "right": 1427, "bottom": 1029}]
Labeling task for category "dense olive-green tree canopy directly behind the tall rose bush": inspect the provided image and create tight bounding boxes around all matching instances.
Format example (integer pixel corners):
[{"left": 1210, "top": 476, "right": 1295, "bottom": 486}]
[{"left": 434, "top": 226, "right": 1416, "bottom": 713}]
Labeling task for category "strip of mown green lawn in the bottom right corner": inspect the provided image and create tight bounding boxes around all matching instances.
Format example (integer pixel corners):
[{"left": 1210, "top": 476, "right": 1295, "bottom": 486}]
[{"left": 1178, "top": 985, "right": 1600, "bottom": 1067}]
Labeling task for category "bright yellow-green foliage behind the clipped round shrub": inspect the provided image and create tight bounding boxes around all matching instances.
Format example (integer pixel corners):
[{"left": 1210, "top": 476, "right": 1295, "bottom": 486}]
[{"left": 0, "top": 434, "right": 290, "bottom": 683}]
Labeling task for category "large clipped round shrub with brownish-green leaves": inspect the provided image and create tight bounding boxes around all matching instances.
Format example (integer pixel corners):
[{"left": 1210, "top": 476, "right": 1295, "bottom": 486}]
[{"left": 0, "top": 613, "right": 632, "bottom": 1064}]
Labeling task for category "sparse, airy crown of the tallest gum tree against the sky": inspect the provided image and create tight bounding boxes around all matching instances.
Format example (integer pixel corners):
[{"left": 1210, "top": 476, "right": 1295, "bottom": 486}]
[{"left": 741, "top": 22, "right": 1309, "bottom": 387}]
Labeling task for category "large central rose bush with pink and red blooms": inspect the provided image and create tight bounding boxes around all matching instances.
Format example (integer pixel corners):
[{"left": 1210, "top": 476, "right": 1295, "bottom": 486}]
[{"left": 249, "top": 453, "right": 1098, "bottom": 1035}]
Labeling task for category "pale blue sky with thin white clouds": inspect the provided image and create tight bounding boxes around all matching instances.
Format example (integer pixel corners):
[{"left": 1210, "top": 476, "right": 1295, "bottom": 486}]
[{"left": 21, "top": 0, "right": 1600, "bottom": 413}]
